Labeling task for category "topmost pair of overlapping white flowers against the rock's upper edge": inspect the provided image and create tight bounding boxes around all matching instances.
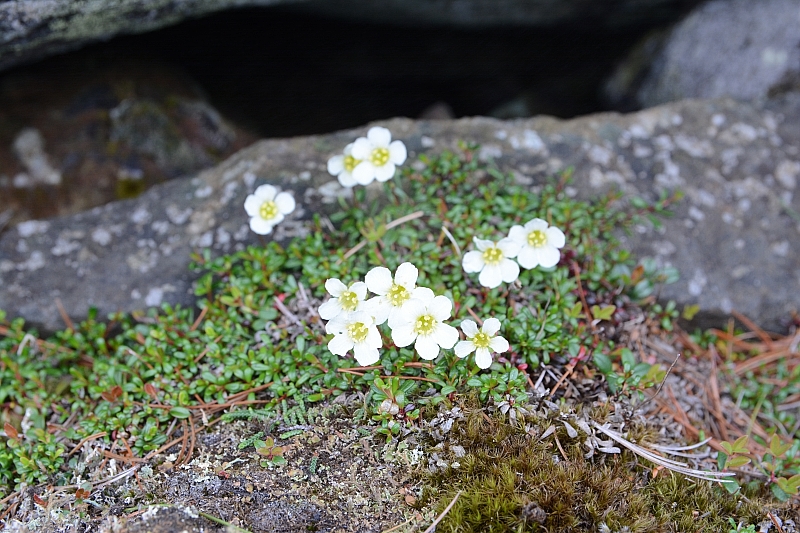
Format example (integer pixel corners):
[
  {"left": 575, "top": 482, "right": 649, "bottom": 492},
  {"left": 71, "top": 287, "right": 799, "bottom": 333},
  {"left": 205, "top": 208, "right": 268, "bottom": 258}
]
[{"left": 328, "top": 126, "right": 408, "bottom": 187}]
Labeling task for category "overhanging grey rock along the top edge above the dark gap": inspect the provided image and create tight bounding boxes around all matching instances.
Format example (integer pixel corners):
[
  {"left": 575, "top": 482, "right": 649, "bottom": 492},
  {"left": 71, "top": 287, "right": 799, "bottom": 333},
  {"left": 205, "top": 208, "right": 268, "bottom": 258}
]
[{"left": 0, "top": 0, "right": 696, "bottom": 70}]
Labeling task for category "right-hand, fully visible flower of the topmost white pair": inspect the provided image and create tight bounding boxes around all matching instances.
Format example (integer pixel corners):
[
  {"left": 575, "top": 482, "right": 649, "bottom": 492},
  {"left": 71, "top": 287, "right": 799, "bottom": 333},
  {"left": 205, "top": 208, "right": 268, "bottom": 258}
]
[{"left": 351, "top": 126, "right": 407, "bottom": 185}]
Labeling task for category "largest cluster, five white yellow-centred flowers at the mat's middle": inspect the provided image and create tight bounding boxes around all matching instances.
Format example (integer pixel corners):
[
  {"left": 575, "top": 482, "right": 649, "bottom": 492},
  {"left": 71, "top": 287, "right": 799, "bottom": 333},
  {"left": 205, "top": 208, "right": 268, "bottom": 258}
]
[{"left": 319, "top": 263, "right": 509, "bottom": 368}]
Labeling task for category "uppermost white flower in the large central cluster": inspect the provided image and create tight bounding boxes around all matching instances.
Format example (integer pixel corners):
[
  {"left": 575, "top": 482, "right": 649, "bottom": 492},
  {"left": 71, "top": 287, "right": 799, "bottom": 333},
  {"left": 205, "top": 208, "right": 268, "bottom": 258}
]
[{"left": 364, "top": 262, "right": 419, "bottom": 329}]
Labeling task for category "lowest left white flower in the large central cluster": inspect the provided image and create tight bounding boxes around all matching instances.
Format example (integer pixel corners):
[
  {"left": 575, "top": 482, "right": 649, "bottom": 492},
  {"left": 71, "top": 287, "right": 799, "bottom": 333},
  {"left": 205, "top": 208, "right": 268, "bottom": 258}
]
[{"left": 325, "top": 311, "right": 383, "bottom": 366}]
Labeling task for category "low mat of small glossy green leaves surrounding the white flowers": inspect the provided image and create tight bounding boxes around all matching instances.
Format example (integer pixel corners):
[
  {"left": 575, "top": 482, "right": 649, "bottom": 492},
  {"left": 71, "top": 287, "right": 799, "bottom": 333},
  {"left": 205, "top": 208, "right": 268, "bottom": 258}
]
[{"left": 0, "top": 147, "right": 674, "bottom": 492}]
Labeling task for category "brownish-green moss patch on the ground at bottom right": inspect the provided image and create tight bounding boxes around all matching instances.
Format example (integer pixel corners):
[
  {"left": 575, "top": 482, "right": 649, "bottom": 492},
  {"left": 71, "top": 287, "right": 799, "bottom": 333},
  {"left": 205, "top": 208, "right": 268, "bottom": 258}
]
[{"left": 425, "top": 409, "right": 767, "bottom": 533}]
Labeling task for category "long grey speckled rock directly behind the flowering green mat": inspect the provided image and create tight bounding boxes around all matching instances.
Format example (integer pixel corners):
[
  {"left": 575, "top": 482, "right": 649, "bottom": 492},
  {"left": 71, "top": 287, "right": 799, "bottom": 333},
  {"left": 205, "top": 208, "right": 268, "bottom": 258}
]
[{"left": 0, "top": 94, "right": 800, "bottom": 330}]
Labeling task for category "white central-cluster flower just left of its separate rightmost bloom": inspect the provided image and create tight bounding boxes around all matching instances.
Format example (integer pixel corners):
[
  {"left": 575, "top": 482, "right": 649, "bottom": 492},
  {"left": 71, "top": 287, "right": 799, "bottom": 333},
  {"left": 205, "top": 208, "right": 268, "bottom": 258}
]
[{"left": 392, "top": 287, "right": 458, "bottom": 360}]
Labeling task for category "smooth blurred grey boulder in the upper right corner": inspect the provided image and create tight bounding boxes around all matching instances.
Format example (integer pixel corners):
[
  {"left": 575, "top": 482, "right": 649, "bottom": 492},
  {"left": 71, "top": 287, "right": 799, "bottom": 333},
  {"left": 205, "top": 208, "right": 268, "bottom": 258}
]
[{"left": 606, "top": 0, "right": 800, "bottom": 108}]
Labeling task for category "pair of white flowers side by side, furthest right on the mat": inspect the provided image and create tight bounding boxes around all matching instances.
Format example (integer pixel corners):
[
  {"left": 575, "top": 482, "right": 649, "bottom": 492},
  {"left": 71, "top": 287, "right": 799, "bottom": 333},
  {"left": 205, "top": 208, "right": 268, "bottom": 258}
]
[{"left": 462, "top": 218, "right": 566, "bottom": 289}]
